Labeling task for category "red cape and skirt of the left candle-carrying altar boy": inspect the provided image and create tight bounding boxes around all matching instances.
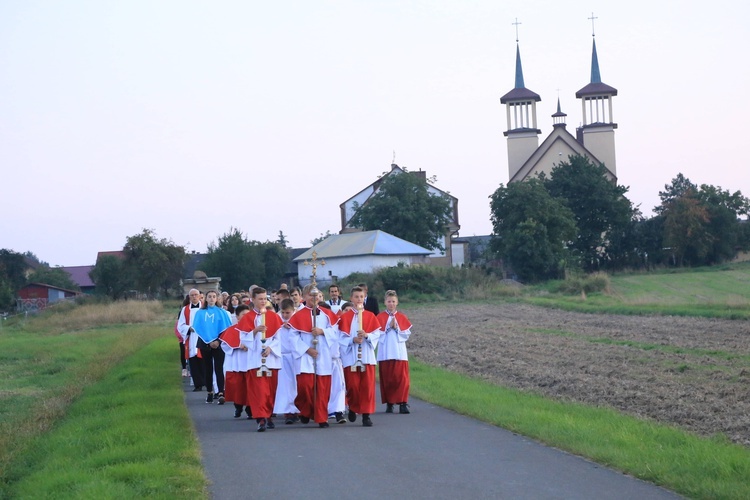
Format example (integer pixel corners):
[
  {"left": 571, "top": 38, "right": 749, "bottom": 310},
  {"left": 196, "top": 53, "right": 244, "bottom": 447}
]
[{"left": 237, "top": 309, "right": 283, "bottom": 418}]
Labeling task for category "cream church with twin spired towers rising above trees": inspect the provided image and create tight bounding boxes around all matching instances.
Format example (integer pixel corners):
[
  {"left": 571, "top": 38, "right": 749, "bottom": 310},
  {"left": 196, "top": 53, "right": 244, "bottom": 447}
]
[{"left": 500, "top": 34, "right": 617, "bottom": 184}]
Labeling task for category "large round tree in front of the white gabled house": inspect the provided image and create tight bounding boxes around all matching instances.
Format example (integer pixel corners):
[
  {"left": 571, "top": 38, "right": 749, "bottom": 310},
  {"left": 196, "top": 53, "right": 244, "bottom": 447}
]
[{"left": 351, "top": 172, "right": 452, "bottom": 250}]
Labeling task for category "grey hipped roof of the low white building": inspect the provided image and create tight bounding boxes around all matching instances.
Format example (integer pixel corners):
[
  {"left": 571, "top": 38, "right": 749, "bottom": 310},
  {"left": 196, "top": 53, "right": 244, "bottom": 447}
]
[{"left": 294, "top": 230, "right": 432, "bottom": 262}]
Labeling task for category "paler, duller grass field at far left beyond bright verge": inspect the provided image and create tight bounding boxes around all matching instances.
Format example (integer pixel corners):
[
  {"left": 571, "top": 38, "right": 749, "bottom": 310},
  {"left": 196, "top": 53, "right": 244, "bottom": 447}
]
[{"left": 0, "top": 320, "right": 164, "bottom": 486}]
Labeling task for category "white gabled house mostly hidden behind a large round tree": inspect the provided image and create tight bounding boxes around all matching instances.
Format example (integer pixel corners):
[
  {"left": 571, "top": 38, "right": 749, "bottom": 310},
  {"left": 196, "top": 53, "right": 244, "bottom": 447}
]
[{"left": 339, "top": 163, "right": 461, "bottom": 266}]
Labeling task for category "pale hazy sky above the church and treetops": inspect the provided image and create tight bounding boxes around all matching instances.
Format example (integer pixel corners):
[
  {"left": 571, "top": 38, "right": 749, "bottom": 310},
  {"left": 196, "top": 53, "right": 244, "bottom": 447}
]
[{"left": 0, "top": 0, "right": 750, "bottom": 266}]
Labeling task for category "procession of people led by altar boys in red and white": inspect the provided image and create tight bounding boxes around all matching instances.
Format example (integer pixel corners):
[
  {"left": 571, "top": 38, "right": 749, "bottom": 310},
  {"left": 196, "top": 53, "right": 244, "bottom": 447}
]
[{"left": 175, "top": 284, "right": 411, "bottom": 432}]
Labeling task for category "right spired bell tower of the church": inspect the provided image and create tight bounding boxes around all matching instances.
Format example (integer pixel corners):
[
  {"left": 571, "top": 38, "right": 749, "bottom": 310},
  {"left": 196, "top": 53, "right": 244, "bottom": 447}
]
[{"left": 576, "top": 34, "right": 617, "bottom": 178}]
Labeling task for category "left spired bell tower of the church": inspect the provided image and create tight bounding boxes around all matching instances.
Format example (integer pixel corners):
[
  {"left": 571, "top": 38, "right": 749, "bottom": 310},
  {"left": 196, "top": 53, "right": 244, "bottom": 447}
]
[{"left": 500, "top": 40, "right": 542, "bottom": 179}]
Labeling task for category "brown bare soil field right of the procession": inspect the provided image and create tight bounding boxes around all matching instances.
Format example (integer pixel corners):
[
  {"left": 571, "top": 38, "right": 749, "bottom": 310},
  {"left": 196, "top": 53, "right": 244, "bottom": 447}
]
[{"left": 405, "top": 304, "right": 750, "bottom": 446}]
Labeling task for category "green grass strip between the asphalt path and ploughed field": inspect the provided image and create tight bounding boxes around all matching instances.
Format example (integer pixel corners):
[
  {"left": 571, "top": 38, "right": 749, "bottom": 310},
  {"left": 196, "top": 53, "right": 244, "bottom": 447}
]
[{"left": 409, "top": 358, "right": 750, "bottom": 499}]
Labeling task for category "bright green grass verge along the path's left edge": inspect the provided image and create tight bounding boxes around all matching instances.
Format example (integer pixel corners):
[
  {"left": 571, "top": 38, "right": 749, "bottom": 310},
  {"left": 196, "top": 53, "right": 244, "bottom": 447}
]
[{"left": 8, "top": 337, "right": 208, "bottom": 499}]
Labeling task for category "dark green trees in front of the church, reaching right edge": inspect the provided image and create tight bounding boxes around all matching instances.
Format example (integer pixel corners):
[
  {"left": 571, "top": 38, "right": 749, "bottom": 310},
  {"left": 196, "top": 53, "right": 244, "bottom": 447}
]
[{"left": 490, "top": 156, "right": 750, "bottom": 281}]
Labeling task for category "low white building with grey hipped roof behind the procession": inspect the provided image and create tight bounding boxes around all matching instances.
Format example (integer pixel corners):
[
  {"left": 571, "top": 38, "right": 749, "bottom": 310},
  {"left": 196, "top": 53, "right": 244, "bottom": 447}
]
[{"left": 294, "top": 231, "right": 432, "bottom": 286}]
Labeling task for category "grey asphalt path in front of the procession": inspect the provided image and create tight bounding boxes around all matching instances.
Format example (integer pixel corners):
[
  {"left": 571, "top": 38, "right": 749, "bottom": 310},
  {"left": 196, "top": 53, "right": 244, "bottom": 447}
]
[{"left": 185, "top": 388, "right": 679, "bottom": 500}]
